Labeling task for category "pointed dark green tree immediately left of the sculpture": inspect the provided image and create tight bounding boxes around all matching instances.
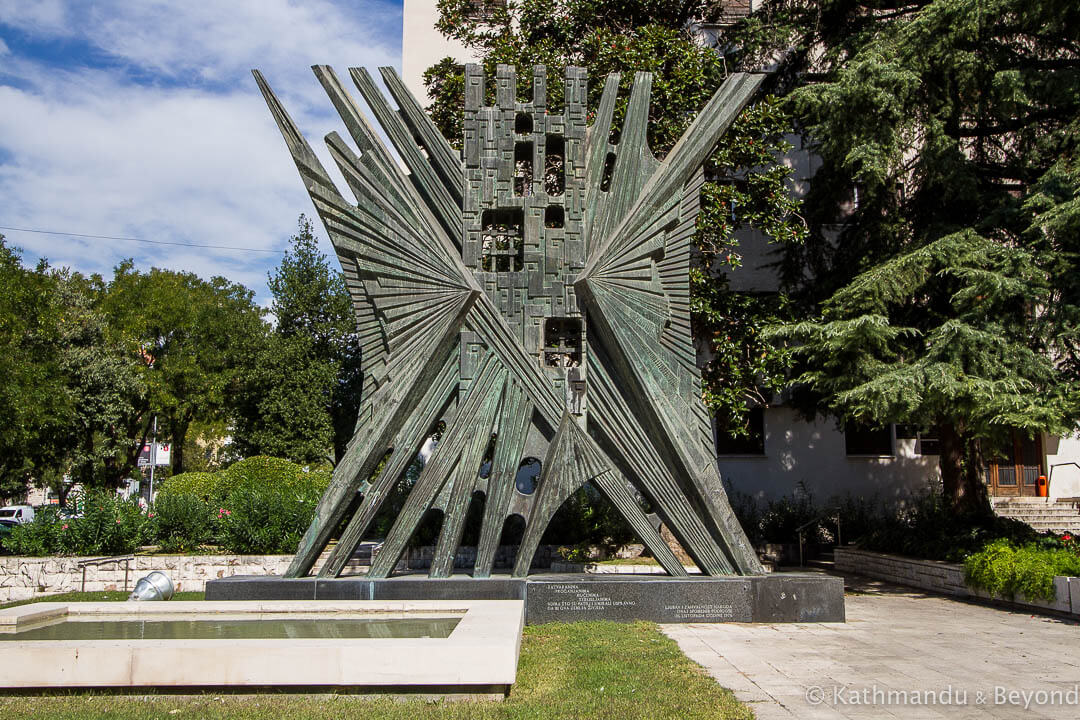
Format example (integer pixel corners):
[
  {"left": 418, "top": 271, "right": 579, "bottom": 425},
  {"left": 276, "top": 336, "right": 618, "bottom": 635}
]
[{"left": 234, "top": 215, "right": 362, "bottom": 463}]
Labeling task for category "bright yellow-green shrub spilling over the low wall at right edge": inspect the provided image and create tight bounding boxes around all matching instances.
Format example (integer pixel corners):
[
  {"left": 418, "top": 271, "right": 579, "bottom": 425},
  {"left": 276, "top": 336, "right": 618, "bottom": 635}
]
[{"left": 963, "top": 540, "right": 1080, "bottom": 601}]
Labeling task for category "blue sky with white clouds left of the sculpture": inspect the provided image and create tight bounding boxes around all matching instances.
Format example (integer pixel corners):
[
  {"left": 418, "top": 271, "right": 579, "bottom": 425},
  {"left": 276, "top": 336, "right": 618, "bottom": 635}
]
[{"left": 0, "top": 0, "right": 402, "bottom": 302}]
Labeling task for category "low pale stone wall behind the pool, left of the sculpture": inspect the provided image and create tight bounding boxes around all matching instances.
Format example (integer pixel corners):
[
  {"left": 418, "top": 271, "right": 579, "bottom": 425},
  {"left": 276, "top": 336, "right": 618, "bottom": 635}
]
[{"left": 0, "top": 555, "right": 293, "bottom": 602}]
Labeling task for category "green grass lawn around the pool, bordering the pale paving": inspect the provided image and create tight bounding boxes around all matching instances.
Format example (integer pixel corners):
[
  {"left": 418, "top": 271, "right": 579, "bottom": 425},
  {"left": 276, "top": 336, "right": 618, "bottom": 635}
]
[{"left": 0, "top": 593, "right": 754, "bottom": 720}]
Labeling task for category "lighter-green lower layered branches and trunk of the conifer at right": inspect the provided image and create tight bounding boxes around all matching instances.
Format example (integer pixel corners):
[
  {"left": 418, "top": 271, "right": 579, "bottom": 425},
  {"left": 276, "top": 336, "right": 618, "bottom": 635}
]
[{"left": 771, "top": 231, "right": 1077, "bottom": 513}]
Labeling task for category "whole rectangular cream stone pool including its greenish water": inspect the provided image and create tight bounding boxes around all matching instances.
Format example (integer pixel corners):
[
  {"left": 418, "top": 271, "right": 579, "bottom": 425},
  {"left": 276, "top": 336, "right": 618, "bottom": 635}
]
[{"left": 0, "top": 600, "right": 525, "bottom": 699}]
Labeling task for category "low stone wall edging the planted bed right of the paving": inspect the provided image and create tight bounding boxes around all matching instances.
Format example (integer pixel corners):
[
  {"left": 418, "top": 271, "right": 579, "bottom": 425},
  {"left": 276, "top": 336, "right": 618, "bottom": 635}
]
[{"left": 834, "top": 547, "right": 1080, "bottom": 617}]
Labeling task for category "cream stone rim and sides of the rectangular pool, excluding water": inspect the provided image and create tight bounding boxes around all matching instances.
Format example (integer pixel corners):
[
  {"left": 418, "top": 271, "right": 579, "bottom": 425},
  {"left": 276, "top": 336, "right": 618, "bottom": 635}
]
[{"left": 0, "top": 600, "right": 525, "bottom": 696}]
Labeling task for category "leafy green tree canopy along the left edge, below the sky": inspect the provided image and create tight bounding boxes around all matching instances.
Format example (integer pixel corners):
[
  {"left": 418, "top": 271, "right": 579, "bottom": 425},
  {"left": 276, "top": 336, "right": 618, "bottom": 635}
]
[{"left": 0, "top": 237, "right": 264, "bottom": 501}]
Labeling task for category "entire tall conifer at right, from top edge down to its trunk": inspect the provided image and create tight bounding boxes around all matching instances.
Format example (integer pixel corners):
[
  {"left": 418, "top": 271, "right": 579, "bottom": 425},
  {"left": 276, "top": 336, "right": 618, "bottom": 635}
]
[{"left": 741, "top": 0, "right": 1080, "bottom": 512}]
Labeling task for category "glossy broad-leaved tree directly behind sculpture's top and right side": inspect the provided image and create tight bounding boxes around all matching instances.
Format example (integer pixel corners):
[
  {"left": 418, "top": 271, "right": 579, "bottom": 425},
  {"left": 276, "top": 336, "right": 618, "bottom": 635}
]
[{"left": 424, "top": 0, "right": 805, "bottom": 434}]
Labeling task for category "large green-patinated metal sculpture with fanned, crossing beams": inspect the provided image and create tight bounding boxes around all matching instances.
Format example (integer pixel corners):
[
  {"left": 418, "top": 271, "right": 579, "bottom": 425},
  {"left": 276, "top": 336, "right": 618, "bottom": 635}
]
[{"left": 255, "top": 65, "right": 762, "bottom": 579}]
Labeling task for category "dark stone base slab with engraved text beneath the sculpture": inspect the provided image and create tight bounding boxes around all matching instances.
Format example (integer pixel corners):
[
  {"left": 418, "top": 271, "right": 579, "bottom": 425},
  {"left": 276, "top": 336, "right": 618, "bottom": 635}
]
[{"left": 206, "top": 572, "right": 845, "bottom": 625}]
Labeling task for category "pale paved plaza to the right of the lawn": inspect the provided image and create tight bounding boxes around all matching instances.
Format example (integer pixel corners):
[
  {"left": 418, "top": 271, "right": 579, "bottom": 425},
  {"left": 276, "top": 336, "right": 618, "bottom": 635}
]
[{"left": 662, "top": 579, "right": 1080, "bottom": 720}]
